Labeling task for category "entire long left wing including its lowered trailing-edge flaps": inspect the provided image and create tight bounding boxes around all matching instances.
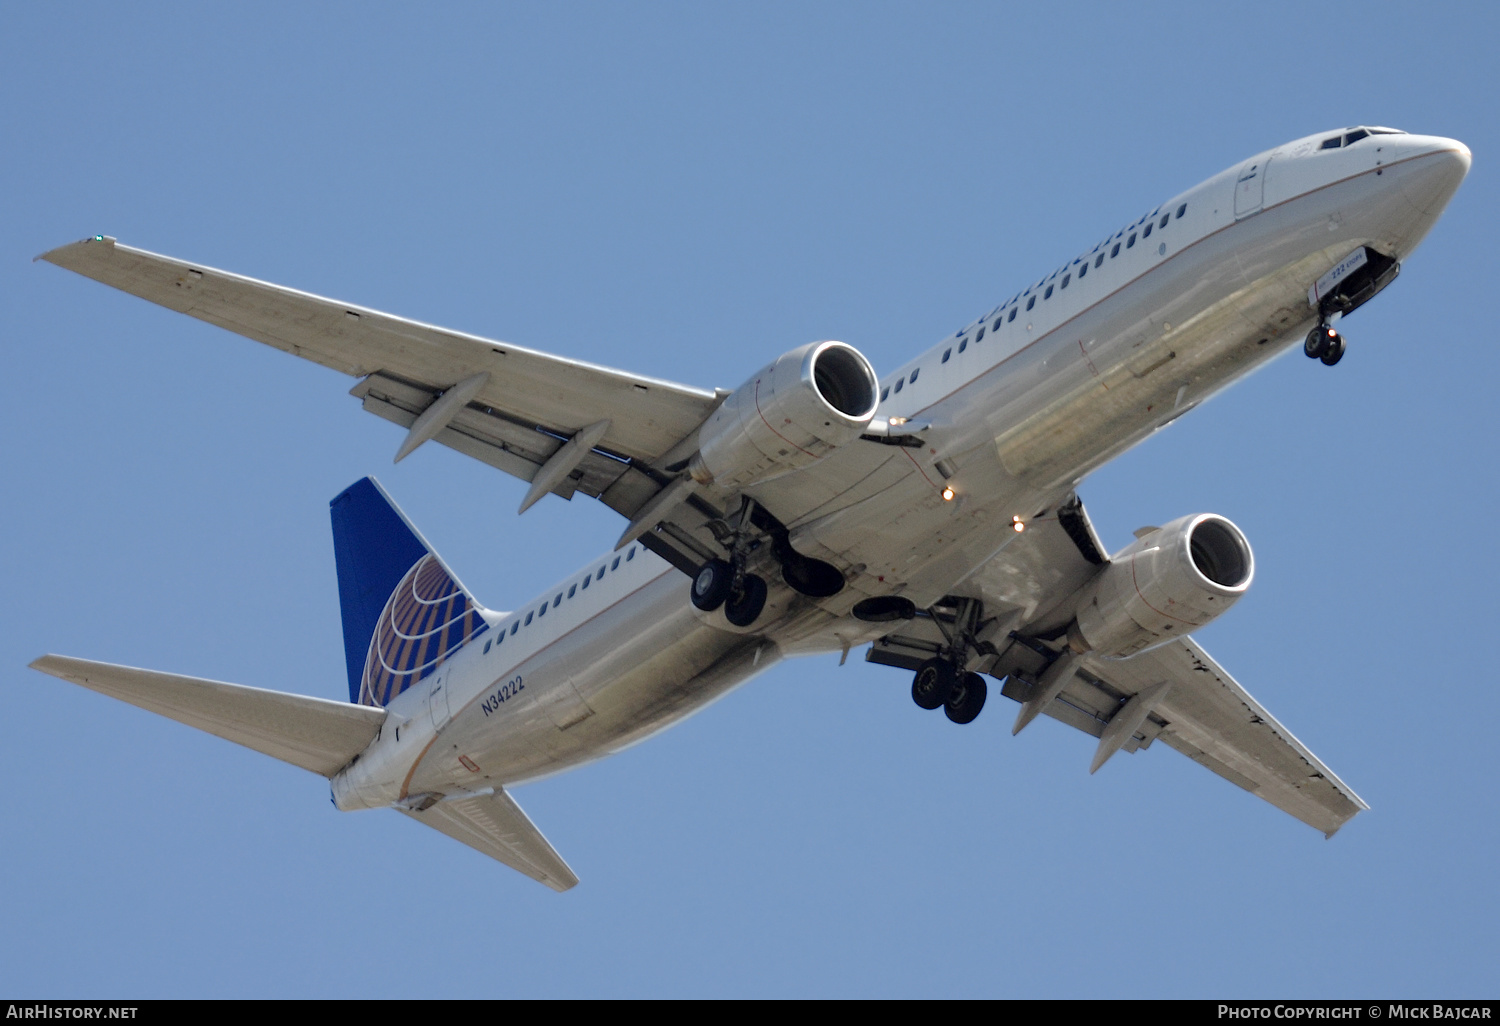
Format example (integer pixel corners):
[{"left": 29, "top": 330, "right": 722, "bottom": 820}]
[{"left": 38, "top": 236, "right": 723, "bottom": 528}]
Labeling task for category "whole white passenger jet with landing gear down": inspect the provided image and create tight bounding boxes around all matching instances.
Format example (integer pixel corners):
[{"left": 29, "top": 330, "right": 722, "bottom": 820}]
[{"left": 32, "top": 126, "right": 1470, "bottom": 891}]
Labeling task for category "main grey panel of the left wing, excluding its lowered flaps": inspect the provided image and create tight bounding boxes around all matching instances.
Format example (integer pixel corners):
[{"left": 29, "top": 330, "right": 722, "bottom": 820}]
[{"left": 41, "top": 236, "right": 719, "bottom": 459}]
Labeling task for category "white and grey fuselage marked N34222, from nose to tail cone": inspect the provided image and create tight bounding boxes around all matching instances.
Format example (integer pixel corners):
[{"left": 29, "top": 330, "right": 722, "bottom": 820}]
[{"left": 333, "top": 134, "right": 1469, "bottom": 809}]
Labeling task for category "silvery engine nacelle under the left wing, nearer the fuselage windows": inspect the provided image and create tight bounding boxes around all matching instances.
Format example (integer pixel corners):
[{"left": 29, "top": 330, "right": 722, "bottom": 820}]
[{"left": 689, "top": 342, "right": 881, "bottom": 491}]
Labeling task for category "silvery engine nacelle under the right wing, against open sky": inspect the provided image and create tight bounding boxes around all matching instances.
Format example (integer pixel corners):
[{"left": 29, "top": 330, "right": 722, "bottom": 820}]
[{"left": 1068, "top": 513, "right": 1256, "bottom": 659}]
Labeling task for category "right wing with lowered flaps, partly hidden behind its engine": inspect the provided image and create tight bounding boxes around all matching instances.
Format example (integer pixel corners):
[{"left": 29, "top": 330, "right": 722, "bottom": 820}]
[{"left": 866, "top": 497, "right": 1370, "bottom": 837}]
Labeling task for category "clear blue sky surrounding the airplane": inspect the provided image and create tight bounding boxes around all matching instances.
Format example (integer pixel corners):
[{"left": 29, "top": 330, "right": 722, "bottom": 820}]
[{"left": 0, "top": 3, "right": 1500, "bottom": 998}]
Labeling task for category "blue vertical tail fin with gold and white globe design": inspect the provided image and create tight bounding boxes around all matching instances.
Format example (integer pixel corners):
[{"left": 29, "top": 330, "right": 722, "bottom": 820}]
[{"left": 329, "top": 477, "right": 489, "bottom": 707}]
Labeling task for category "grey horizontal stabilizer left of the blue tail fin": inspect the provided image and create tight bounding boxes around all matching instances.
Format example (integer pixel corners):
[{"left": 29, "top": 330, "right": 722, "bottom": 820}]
[{"left": 32, "top": 656, "right": 386, "bottom": 777}]
